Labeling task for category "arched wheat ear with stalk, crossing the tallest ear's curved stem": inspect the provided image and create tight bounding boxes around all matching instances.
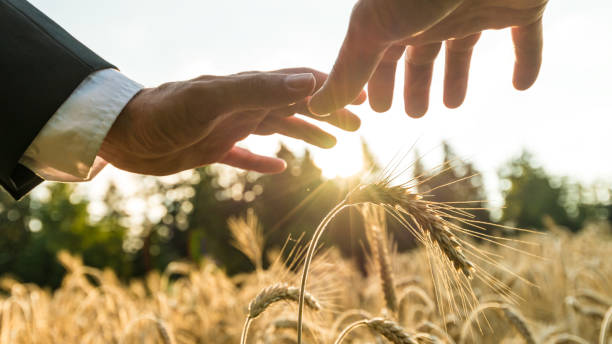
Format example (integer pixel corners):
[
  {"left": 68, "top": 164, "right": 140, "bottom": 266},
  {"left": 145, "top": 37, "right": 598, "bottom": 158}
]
[{"left": 240, "top": 283, "right": 321, "bottom": 344}]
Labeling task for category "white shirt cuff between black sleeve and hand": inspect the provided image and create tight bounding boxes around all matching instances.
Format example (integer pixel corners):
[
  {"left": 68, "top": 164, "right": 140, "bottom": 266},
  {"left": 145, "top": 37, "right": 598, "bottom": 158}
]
[{"left": 19, "top": 69, "right": 143, "bottom": 182}]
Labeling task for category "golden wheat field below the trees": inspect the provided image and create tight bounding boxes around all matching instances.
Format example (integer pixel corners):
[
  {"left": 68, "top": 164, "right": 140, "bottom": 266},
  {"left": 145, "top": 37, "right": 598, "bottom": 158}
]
[{"left": 0, "top": 202, "right": 612, "bottom": 344}]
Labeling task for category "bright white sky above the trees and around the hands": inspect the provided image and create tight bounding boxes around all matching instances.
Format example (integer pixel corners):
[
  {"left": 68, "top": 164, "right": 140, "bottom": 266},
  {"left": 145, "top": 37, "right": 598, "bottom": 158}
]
[{"left": 31, "top": 0, "right": 612, "bottom": 207}]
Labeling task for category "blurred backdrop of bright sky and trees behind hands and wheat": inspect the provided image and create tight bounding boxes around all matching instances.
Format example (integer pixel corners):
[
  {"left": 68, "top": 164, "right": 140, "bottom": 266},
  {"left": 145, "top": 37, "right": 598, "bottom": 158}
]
[{"left": 0, "top": 0, "right": 612, "bottom": 287}]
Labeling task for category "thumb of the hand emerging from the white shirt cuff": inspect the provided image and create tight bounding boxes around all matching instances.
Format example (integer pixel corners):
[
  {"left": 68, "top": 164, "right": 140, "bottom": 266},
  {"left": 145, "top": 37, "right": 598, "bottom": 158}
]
[{"left": 221, "top": 73, "right": 316, "bottom": 111}]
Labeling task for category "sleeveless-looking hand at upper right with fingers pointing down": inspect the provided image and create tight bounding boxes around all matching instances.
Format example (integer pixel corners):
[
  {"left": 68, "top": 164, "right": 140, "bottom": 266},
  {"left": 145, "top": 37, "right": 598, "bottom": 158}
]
[{"left": 309, "top": 0, "right": 547, "bottom": 117}]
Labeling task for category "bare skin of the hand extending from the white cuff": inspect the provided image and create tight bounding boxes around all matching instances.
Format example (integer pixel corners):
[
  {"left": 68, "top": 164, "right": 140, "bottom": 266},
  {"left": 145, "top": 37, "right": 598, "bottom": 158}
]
[{"left": 99, "top": 68, "right": 365, "bottom": 175}]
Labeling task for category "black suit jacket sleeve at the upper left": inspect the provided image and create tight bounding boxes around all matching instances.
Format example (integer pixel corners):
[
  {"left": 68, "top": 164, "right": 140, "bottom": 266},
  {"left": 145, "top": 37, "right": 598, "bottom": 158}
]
[{"left": 0, "top": 0, "right": 113, "bottom": 199}]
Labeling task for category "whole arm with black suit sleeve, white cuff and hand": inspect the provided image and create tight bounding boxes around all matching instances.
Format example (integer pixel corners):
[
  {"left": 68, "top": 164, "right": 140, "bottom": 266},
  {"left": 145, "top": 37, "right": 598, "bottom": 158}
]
[{"left": 0, "top": 0, "right": 365, "bottom": 199}]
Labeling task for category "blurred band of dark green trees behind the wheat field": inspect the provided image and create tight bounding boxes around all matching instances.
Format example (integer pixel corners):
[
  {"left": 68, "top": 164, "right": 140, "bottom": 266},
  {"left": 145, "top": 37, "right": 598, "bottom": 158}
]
[{"left": 0, "top": 144, "right": 612, "bottom": 287}]
